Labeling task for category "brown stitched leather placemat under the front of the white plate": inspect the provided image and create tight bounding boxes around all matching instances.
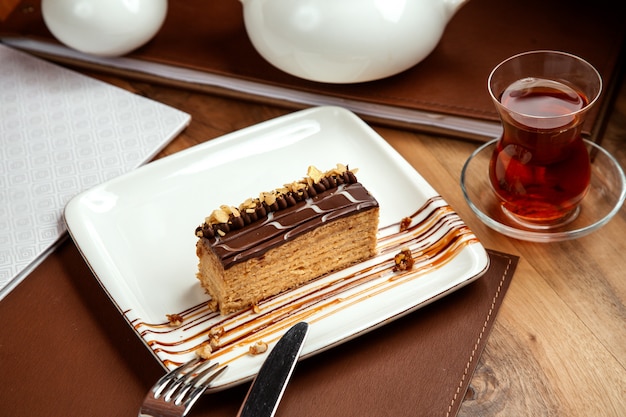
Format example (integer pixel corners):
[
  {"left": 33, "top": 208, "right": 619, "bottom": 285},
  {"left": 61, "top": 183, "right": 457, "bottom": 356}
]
[{"left": 0, "top": 239, "right": 518, "bottom": 417}]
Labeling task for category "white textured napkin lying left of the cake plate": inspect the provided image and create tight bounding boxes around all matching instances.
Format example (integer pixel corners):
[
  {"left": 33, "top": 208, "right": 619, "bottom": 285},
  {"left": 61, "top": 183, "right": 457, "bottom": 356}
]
[{"left": 0, "top": 44, "right": 190, "bottom": 299}]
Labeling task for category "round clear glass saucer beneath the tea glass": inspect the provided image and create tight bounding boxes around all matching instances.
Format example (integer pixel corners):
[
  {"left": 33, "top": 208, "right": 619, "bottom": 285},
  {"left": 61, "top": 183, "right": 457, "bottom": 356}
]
[{"left": 461, "top": 140, "right": 626, "bottom": 242}]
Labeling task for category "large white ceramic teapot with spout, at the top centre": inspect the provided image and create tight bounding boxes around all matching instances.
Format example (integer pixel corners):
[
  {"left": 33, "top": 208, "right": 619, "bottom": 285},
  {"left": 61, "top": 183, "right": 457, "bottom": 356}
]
[{"left": 241, "top": 0, "right": 467, "bottom": 83}]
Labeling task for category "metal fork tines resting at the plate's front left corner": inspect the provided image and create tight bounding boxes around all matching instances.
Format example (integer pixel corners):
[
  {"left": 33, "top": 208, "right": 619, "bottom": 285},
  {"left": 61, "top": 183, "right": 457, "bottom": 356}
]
[{"left": 139, "top": 358, "right": 228, "bottom": 417}]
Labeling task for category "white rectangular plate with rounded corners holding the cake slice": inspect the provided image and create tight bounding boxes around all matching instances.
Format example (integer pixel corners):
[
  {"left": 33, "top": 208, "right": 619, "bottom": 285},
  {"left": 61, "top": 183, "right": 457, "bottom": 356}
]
[{"left": 65, "top": 107, "right": 489, "bottom": 391}]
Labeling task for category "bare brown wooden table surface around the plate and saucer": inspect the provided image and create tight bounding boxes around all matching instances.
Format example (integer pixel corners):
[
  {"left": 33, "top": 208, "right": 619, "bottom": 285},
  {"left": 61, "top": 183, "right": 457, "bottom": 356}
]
[{"left": 0, "top": 65, "right": 626, "bottom": 417}]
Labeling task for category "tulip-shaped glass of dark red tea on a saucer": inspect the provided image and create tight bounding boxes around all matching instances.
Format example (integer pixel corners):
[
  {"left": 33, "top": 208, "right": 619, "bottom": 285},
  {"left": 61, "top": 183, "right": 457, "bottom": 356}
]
[{"left": 488, "top": 51, "right": 602, "bottom": 229}]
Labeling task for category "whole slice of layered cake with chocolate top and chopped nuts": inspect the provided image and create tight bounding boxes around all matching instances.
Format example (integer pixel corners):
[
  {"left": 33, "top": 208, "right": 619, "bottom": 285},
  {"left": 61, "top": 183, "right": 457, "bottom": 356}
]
[{"left": 196, "top": 164, "right": 379, "bottom": 314}]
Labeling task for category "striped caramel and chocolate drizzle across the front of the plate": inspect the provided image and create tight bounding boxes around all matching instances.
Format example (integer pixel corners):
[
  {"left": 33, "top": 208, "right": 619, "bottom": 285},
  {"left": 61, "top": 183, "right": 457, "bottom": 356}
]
[{"left": 125, "top": 196, "right": 477, "bottom": 368}]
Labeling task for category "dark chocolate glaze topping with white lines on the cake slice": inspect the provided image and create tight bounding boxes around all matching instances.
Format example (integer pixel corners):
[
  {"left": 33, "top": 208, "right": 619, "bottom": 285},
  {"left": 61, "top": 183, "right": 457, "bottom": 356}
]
[{"left": 196, "top": 167, "right": 378, "bottom": 268}]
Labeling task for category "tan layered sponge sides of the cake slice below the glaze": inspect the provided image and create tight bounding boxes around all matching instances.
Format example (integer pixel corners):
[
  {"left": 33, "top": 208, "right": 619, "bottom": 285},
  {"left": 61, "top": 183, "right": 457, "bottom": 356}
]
[{"left": 197, "top": 207, "right": 379, "bottom": 314}]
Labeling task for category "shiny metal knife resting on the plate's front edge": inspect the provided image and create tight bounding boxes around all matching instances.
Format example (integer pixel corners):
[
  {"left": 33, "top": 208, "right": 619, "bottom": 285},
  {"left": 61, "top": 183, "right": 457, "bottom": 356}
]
[{"left": 237, "top": 322, "right": 309, "bottom": 417}]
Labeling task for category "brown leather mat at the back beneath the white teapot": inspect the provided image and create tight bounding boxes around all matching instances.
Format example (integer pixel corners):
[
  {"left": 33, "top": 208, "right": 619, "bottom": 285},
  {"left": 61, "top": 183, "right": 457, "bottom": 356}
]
[{"left": 0, "top": 0, "right": 626, "bottom": 141}]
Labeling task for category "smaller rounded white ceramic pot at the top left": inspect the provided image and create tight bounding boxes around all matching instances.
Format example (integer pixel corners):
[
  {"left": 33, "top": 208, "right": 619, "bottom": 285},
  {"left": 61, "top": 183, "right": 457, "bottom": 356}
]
[{"left": 41, "top": 0, "right": 167, "bottom": 56}]
